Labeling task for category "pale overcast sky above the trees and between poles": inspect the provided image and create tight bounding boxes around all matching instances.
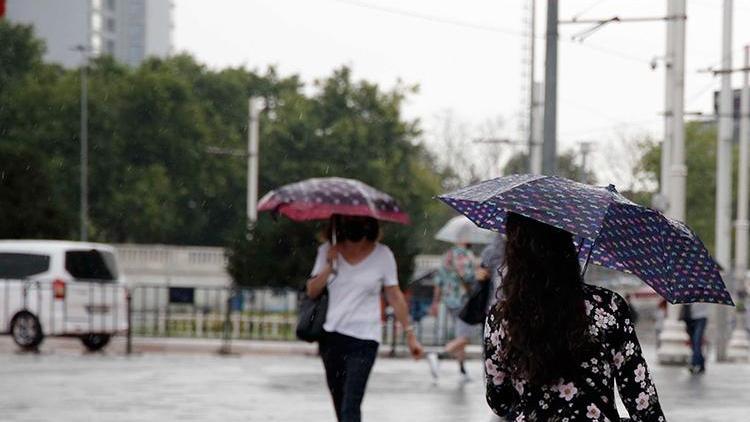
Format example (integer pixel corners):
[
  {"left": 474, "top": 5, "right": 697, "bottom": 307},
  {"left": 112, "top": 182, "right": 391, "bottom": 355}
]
[{"left": 174, "top": 0, "right": 750, "bottom": 186}]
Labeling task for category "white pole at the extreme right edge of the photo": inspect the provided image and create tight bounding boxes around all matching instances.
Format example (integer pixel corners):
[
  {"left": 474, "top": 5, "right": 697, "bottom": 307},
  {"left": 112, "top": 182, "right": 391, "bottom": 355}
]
[{"left": 727, "top": 45, "right": 750, "bottom": 362}]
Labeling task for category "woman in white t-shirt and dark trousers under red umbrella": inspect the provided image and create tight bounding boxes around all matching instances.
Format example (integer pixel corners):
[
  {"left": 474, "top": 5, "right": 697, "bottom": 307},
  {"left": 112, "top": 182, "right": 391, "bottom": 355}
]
[{"left": 307, "top": 215, "right": 423, "bottom": 422}]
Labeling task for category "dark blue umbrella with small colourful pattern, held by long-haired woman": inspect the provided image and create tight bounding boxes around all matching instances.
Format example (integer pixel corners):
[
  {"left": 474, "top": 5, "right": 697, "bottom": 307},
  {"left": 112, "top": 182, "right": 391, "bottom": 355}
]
[{"left": 439, "top": 174, "right": 733, "bottom": 305}]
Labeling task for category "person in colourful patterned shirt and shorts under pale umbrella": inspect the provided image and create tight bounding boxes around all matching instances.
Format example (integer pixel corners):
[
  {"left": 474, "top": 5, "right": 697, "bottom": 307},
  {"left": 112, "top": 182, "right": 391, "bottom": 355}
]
[{"left": 427, "top": 243, "right": 479, "bottom": 381}]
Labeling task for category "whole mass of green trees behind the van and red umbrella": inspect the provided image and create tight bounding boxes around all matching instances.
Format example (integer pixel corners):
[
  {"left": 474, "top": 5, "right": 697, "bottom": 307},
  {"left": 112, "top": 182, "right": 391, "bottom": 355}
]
[{"left": 0, "top": 21, "right": 450, "bottom": 285}]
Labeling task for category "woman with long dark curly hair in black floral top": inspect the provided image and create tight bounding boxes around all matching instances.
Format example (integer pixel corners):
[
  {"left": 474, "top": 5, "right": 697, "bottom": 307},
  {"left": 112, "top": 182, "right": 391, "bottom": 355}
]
[{"left": 484, "top": 213, "right": 665, "bottom": 421}]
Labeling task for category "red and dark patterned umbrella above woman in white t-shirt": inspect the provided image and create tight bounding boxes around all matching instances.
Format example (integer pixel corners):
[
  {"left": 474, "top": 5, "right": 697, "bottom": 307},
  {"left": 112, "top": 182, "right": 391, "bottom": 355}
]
[{"left": 258, "top": 177, "right": 409, "bottom": 224}]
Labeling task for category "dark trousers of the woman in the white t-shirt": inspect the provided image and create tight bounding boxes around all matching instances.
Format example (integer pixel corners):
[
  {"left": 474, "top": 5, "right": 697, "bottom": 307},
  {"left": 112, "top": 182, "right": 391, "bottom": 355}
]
[{"left": 319, "top": 333, "right": 378, "bottom": 422}]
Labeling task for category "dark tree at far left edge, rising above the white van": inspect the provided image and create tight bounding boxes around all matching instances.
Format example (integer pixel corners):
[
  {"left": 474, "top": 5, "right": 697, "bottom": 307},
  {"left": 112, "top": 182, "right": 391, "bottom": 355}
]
[{"left": 0, "top": 20, "right": 75, "bottom": 238}]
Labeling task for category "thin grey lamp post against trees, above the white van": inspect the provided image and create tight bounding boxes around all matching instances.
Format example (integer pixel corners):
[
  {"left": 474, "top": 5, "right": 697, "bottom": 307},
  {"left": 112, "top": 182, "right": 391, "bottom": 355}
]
[{"left": 74, "top": 45, "right": 89, "bottom": 242}]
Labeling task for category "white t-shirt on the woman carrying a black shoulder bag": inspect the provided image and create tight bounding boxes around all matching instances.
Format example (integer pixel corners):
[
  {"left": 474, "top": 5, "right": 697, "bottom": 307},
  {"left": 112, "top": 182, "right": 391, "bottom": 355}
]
[{"left": 312, "top": 243, "right": 398, "bottom": 343}]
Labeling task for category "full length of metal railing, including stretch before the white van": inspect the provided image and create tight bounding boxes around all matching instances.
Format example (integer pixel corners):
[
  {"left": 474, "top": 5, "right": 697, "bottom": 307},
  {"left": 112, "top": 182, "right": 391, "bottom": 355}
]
[{"left": 0, "top": 280, "right": 476, "bottom": 351}]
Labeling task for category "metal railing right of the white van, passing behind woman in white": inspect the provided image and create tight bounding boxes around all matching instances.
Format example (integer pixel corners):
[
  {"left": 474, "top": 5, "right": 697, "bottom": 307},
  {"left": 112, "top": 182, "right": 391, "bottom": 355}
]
[{"left": 130, "top": 285, "right": 470, "bottom": 347}]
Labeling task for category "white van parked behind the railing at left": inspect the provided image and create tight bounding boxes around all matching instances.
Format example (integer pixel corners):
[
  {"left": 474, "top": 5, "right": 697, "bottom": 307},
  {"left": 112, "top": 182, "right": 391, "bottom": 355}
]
[{"left": 0, "top": 240, "right": 128, "bottom": 351}]
